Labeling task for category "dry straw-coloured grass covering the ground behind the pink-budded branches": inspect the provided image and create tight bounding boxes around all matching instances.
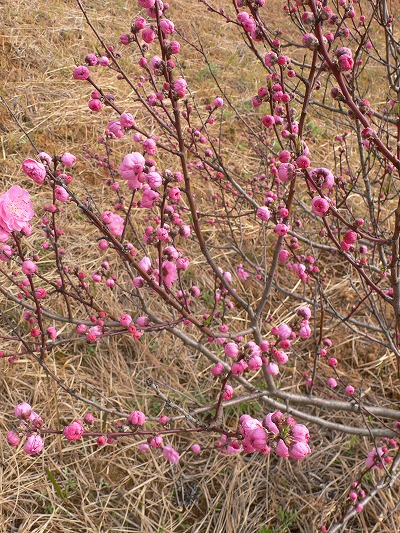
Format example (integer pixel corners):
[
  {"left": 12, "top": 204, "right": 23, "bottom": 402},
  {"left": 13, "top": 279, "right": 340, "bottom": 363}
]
[{"left": 0, "top": 0, "right": 400, "bottom": 533}]
